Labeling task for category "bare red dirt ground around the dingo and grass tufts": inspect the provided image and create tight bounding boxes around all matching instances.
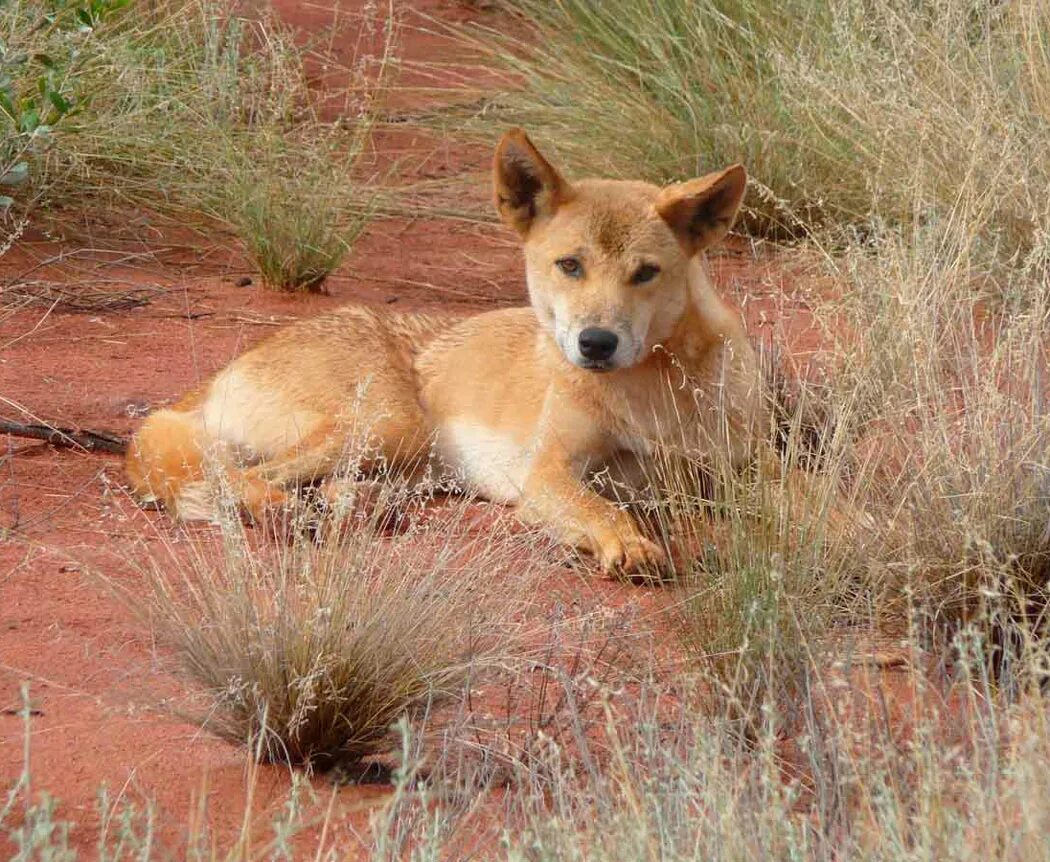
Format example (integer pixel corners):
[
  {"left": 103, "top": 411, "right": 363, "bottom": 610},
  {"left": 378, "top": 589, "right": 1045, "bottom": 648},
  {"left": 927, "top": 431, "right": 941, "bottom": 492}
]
[{"left": 0, "top": 0, "right": 902, "bottom": 852}]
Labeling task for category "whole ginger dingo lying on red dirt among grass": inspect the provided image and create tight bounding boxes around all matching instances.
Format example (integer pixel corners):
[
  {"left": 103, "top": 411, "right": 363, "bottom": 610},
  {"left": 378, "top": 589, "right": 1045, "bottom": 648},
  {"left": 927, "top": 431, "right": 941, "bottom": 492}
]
[{"left": 127, "top": 129, "right": 764, "bottom": 571}]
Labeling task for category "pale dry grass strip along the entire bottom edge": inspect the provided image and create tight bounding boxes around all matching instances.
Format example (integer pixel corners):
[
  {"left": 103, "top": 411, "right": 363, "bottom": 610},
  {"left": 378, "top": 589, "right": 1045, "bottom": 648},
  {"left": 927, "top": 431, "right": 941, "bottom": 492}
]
[{"left": 12, "top": 653, "right": 1050, "bottom": 862}]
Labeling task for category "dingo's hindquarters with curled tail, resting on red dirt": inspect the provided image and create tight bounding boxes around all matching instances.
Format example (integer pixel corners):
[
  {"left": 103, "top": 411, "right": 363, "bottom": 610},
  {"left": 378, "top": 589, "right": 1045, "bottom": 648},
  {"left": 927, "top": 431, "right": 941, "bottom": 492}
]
[{"left": 127, "top": 308, "right": 444, "bottom": 519}]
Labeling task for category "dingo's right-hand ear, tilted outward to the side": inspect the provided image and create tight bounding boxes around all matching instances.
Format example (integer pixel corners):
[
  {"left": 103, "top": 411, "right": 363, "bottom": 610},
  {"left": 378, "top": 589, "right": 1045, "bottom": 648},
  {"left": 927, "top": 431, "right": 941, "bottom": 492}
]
[{"left": 656, "top": 165, "right": 748, "bottom": 256}]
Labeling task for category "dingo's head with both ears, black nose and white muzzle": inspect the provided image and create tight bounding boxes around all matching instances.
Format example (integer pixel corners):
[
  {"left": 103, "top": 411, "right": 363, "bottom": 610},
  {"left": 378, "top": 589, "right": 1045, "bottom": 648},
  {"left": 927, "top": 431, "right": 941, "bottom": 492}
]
[{"left": 495, "top": 129, "right": 747, "bottom": 371}]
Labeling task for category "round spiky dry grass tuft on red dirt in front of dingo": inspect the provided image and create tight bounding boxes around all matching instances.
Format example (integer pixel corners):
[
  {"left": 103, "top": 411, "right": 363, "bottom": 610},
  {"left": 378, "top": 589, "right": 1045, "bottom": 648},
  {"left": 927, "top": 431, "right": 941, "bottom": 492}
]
[{"left": 137, "top": 480, "right": 544, "bottom": 769}]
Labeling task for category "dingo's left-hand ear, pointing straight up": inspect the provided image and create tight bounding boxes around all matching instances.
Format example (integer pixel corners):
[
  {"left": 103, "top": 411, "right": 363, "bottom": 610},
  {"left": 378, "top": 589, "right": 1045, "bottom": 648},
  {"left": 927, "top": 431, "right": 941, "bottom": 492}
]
[{"left": 492, "top": 129, "right": 568, "bottom": 236}]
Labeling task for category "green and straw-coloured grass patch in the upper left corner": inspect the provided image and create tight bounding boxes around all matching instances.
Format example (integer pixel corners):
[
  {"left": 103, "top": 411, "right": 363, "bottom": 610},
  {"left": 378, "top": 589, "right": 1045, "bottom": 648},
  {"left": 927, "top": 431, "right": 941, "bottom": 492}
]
[{"left": 0, "top": 0, "right": 396, "bottom": 290}]
